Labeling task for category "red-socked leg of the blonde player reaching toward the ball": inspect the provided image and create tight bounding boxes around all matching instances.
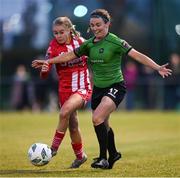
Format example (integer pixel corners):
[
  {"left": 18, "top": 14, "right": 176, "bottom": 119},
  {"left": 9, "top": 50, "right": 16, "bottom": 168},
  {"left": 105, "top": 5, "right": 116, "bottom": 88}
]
[{"left": 51, "top": 94, "right": 83, "bottom": 156}]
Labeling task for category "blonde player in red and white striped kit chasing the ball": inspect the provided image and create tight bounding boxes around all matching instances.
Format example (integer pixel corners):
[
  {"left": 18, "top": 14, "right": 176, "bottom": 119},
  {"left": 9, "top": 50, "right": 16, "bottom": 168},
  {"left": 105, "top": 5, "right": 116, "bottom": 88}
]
[{"left": 40, "top": 17, "right": 92, "bottom": 168}]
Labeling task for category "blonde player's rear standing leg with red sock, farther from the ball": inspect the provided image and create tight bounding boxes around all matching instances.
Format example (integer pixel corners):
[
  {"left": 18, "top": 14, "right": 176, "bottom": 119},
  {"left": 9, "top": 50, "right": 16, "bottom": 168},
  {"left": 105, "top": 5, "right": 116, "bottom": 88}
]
[{"left": 69, "top": 111, "right": 87, "bottom": 168}]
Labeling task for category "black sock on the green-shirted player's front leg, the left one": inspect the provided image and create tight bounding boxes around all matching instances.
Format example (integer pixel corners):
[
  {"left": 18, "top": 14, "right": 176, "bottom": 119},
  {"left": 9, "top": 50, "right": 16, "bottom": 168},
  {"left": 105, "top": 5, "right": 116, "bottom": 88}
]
[{"left": 94, "top": 122, "right": 108, "bottom": 159}]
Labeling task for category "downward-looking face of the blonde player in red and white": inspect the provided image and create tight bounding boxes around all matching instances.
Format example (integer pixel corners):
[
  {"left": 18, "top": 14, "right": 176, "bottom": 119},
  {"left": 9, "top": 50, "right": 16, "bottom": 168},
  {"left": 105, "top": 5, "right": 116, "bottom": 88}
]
[{"left": 52, "top": 25, "right": 71, "bottom": 44}]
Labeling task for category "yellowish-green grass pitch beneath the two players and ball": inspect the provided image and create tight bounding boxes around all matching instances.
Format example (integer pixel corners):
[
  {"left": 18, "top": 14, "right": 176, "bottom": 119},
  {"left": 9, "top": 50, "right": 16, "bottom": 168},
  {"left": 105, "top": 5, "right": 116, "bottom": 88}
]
[{"left": 0, "top": 111, "right": 180, "bottom": 177}]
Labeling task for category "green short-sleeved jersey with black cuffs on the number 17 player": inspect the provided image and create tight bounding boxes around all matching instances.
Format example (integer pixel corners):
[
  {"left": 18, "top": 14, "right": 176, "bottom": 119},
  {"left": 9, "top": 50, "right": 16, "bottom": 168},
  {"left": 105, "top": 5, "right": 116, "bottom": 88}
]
[{"left": 74, "top": 33, "right": 132, "bottom": 88}]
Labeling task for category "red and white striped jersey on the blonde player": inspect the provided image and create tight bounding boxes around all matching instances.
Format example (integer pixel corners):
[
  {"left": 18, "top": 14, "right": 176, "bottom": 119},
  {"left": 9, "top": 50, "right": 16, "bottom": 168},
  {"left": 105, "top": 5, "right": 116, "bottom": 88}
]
[{"left": 46, "top": 38, "right": 91, "bottom": 93}]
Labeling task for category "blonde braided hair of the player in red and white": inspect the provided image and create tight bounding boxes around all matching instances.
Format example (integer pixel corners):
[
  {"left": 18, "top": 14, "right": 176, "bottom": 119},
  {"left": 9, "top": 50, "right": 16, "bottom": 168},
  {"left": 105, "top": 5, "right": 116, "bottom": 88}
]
[{"left": 53, "top": 16, "right": 80, "bottom": 37}]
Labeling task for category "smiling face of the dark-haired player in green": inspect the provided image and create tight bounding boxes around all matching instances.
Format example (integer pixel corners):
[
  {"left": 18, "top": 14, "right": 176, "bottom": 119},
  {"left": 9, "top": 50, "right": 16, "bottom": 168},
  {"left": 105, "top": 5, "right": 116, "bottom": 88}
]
[{"left": 89, "top": 18, "right": 110, "bottom": 40}]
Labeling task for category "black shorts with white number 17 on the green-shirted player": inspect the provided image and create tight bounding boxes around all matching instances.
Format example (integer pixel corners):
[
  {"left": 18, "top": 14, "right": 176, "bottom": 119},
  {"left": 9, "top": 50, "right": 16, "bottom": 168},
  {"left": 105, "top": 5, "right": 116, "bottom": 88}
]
[{"left": 91, "top": 81, "right": 126, "bottom": 110}]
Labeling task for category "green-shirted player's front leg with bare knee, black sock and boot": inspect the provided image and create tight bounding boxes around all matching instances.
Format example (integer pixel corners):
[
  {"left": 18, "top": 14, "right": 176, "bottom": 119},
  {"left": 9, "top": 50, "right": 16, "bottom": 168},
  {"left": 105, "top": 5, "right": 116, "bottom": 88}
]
[{"left": 91, "top": 96, "right": 116, "bottom": 169}]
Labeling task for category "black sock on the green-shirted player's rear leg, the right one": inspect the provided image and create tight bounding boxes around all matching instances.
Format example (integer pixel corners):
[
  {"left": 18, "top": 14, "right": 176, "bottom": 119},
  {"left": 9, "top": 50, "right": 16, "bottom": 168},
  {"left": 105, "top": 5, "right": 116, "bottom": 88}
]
[{"left": 108, "top": 128, "right": 117, "bottom": 157}]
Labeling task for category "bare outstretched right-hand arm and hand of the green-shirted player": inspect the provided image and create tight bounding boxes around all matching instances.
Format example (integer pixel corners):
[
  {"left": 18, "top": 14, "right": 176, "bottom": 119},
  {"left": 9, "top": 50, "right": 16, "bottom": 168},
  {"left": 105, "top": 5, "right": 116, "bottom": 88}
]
[{"left": 128, "top": 48, "right": 172, "bottom": 78}]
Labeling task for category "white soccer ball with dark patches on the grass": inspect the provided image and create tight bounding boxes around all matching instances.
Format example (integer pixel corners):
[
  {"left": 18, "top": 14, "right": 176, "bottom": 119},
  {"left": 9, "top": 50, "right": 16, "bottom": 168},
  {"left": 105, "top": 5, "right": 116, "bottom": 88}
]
[{"left": 28, "top": 143, "right": 52, "bottom": 166}]
